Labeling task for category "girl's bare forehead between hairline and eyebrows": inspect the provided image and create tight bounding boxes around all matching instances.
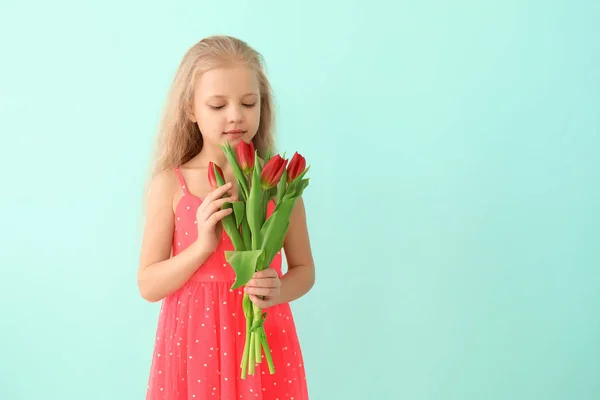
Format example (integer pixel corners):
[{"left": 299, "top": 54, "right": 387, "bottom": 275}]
[{"left": 196, "top": 66, "right": 259, "bottom": 97}]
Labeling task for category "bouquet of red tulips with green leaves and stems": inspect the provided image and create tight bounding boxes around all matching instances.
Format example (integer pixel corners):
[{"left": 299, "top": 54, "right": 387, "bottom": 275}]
[{"left": 208, "top": 140, "right": 310, "bottom": 379}]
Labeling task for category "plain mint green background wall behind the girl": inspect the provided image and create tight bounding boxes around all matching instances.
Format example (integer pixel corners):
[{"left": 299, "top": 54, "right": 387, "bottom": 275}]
[{"left": 0, "top": 0, "right": 600, "bottom": 400}]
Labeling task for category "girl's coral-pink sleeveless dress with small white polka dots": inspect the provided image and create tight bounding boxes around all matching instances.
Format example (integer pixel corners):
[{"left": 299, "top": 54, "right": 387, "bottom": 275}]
[{"left": 146, "top": 168, "right": 308, "bottom": 400}]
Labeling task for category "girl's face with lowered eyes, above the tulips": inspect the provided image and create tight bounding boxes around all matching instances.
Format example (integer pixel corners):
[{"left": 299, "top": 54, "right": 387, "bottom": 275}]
[{"left": 190, "top": 66, "right": 260, "bottom": 148}]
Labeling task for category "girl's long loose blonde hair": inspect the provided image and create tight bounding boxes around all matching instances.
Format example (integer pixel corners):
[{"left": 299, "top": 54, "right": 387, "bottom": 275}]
[{"left": 150, "top": 35, "right": 275, "bottom": 179}]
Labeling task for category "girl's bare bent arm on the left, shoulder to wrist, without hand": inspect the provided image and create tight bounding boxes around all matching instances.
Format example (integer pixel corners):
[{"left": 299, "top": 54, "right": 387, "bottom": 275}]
[{"left": 137, "top": 172, "right": 210, "bottom": 302}]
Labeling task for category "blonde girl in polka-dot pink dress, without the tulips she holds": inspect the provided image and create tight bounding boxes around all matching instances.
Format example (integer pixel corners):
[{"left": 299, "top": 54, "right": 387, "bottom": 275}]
[{"left": 138, "top": 36, "right": 315, "bottom": 400}]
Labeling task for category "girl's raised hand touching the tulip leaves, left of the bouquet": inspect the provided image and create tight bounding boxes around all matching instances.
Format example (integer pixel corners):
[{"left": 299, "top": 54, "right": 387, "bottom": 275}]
[{"left": 196, "top": 182, "right": 237, "bottom": 253}]
